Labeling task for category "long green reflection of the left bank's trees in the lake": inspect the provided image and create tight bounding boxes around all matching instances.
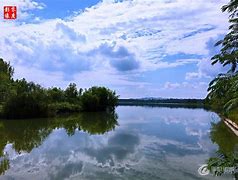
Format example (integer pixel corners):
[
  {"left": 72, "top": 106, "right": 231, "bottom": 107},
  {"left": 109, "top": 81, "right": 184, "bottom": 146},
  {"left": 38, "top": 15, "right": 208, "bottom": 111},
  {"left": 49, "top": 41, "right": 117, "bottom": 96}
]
[{"left": 0, "top": 112, "right": 118, "bottom": 175}]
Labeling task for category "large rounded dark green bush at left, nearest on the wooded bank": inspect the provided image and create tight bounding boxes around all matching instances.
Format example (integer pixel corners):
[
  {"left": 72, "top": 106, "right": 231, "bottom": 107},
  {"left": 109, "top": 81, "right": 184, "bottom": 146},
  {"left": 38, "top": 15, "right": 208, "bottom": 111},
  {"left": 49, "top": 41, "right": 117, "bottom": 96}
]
[{"left": 3, "top": 79, "right": 50, "bottom": 118}]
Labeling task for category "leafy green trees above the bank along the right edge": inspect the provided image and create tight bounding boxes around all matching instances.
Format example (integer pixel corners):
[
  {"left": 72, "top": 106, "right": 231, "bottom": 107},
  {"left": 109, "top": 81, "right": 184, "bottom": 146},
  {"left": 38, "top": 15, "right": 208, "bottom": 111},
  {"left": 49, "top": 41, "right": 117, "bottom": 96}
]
[{"left": 206, "top": 0, "right": 238, "bottom": 122}]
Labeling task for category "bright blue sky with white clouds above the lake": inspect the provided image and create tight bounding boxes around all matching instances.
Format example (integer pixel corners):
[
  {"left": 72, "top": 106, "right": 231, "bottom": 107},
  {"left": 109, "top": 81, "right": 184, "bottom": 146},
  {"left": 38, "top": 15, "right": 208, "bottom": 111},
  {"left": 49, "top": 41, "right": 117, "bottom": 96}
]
[{"left": 0, "top": 0, "right": 231, "bottom": 98}]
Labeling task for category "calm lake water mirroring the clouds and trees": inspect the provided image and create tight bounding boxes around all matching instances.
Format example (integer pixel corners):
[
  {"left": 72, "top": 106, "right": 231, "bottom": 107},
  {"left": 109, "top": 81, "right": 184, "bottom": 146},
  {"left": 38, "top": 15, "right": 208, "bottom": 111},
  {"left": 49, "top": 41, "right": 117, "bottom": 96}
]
[{"left": 0, "top": 106, "right": 238, "bottom": 180}]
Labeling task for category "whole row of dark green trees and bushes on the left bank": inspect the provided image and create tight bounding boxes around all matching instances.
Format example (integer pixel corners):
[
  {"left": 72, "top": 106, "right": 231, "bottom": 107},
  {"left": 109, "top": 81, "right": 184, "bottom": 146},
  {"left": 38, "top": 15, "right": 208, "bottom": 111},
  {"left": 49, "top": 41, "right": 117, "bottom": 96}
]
[{"left": 0, "top": 59, "right": 119, "bottom": 119}]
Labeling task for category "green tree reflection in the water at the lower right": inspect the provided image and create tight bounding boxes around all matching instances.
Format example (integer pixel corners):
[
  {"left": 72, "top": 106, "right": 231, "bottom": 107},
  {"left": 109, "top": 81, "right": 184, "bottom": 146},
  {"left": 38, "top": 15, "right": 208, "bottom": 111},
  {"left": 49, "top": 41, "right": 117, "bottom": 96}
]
[{"left": 208, "top": 121, "right": 238, "bottom": 179}]
